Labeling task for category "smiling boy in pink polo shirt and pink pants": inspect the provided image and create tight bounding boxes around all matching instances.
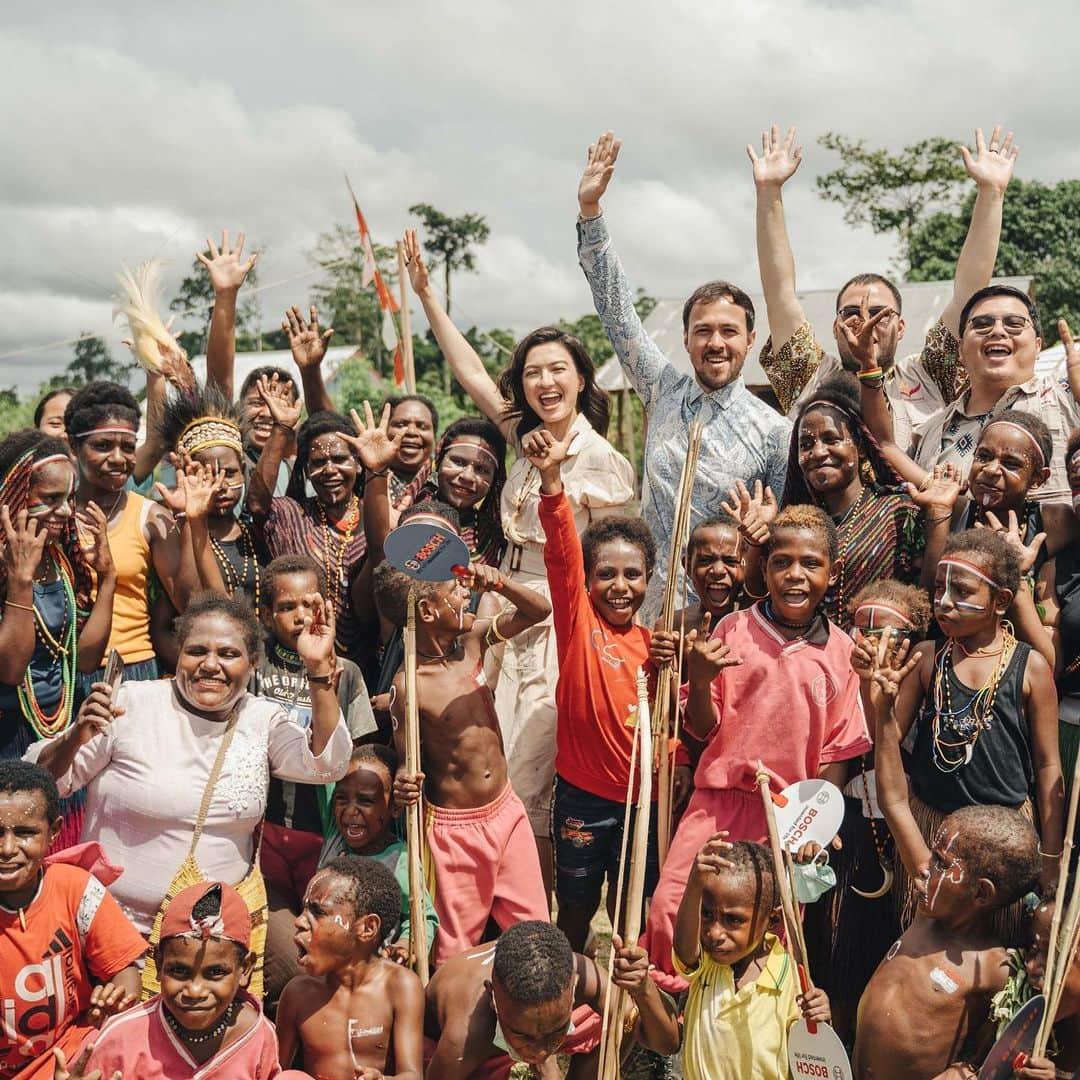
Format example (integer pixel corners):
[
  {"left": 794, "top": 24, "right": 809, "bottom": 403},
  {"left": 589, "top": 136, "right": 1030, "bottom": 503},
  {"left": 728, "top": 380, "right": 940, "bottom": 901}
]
[{"left": 645, "top": 505, "right": 870, "bottom": 989}]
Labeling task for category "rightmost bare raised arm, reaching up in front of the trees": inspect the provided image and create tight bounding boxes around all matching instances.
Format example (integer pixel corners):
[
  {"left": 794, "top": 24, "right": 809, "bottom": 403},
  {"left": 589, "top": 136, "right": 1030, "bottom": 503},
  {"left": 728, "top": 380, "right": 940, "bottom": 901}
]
[{"left": 941, "top": 124, "right": 1020, "bottom": 336}]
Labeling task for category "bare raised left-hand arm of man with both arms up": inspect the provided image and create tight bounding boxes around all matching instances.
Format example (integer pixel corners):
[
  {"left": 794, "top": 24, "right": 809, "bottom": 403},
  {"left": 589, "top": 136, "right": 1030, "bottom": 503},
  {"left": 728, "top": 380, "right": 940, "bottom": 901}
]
[{"left": 746, "top": 124, "right": 812, "bottom": 356}]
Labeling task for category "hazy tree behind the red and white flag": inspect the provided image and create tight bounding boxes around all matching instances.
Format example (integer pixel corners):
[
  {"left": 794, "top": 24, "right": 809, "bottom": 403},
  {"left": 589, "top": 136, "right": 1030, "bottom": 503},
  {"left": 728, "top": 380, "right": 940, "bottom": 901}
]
[{"left": 310, "top": 225, "right": 397, "bottom": 375}]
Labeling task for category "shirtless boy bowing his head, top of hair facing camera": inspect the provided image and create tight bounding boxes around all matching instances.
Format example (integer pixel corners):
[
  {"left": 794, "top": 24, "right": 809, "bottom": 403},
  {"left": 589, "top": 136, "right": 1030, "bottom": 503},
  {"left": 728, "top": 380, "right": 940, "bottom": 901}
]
[{"left": 424, "top": 922, "right": 678, "bottom": 1080}]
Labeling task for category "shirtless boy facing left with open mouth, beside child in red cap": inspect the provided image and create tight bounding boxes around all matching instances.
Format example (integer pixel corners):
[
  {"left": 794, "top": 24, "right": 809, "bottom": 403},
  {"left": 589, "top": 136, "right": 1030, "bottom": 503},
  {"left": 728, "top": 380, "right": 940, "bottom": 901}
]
[{"left": 278, "top": 855, "right": 423, "bottom": 1080}]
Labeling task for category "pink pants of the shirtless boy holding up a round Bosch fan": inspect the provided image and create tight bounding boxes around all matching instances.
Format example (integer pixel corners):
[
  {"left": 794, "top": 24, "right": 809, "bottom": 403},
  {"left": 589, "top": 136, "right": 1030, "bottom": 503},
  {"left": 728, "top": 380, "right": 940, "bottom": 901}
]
[{"left": 427, "top": 784, "right": 551, "bottom": 964}]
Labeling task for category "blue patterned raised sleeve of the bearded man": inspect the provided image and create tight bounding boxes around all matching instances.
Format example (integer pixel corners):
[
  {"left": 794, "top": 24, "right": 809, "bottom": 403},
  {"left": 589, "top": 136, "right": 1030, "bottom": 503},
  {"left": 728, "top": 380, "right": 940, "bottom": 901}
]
[{"left": 578, "top": 215, "right": 676, "bottom": 411}]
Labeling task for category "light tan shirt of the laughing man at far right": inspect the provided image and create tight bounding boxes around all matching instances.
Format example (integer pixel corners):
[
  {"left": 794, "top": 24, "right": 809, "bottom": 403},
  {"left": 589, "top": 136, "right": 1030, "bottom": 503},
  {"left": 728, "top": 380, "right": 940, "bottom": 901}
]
[{"left": 913, "top": 375, "right": 1080, "bottom": 502}]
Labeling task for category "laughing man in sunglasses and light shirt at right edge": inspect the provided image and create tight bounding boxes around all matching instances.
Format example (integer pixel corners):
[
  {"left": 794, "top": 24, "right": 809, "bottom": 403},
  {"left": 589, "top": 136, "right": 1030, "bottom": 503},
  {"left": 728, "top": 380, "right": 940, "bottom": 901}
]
[{"left": 911, "top": 285, "right": 1080, "bottom": 502}]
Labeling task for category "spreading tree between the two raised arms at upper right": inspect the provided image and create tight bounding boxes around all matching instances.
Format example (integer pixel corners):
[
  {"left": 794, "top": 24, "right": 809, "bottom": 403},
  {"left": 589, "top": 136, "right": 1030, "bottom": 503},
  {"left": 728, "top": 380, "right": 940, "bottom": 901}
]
[{"left": 815, "top": 132, "right": 964, "bottom": 271}]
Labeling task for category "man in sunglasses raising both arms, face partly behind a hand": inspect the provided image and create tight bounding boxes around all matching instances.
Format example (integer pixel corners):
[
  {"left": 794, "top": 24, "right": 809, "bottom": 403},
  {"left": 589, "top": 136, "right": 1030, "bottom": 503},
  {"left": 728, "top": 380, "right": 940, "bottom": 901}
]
[{"left": 746, "top": 126, "right": 1017, "bottom": 449}]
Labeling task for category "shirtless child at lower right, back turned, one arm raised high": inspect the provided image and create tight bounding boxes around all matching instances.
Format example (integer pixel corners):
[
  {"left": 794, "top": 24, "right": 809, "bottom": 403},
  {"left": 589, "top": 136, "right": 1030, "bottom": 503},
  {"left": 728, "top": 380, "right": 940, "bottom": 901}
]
[{"left": 854, "top": 640, "right": 1041, "bottom": 1080}]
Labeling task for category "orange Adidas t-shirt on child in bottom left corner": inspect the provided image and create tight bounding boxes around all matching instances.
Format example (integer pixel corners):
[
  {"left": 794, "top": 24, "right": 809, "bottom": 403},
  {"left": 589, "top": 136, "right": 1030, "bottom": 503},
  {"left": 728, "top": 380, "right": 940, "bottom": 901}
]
[{"left": 0, "top": 865, "right": 146, "bottom": 1080}]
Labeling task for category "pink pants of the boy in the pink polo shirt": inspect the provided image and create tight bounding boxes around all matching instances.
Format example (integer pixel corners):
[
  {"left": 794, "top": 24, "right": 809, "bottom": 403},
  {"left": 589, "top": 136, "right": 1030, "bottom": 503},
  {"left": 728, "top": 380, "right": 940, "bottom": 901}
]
[{"left": 640, "top": 787, "right": 768, "bottom": 994}]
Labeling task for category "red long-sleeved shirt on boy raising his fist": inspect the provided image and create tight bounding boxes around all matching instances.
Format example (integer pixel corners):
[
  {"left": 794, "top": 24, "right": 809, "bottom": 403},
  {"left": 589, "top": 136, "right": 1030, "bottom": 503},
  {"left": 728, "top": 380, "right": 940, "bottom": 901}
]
[{"left": 540, "top": 491, "right": 673, "bottom": 802}]
